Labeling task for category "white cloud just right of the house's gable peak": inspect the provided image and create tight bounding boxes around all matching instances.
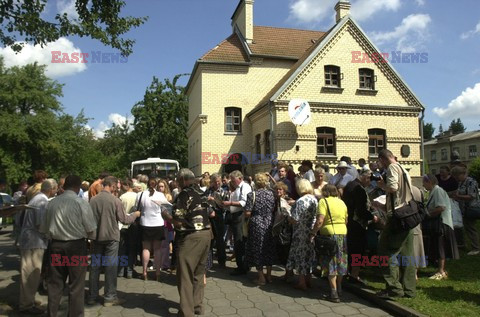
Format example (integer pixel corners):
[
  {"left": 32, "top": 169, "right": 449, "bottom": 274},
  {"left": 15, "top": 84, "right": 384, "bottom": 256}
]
[{"left": 370, "top": 14, "right": 432, "bottom": 53}]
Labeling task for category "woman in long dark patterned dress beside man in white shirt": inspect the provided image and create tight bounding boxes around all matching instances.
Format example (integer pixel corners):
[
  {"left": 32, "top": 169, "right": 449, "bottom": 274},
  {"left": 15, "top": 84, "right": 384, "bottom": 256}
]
[{"left": 245, "top": 173, "right": 275, "bottom": 285}]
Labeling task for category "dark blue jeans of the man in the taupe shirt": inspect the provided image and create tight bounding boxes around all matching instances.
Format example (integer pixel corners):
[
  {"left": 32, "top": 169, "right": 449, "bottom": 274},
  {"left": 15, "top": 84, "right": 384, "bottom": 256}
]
[{"left": 89, "top": 241, "right": 119, "bottom": 301}]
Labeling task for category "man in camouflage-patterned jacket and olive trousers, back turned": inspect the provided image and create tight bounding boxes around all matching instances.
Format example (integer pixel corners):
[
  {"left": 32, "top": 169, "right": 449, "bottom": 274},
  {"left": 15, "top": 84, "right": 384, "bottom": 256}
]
[{"left": 162, "top": 168, "right": 211, "bottom": 317}]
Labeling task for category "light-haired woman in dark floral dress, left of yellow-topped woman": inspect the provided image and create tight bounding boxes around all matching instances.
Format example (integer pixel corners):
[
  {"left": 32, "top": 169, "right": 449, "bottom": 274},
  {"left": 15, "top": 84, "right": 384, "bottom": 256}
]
[{"left": 286, "top": 179, "right": 318, "bottom": 290}]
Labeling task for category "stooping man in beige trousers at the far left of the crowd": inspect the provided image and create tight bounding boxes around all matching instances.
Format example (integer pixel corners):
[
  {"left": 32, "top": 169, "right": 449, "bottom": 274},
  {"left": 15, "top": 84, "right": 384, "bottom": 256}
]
[{"left": 19, "top": 179, "right": 57, "bottom": 315}]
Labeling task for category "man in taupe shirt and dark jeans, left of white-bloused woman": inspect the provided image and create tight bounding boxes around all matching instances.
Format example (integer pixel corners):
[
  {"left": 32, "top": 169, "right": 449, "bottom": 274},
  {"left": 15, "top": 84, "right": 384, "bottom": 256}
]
[{"left": 87, "top": 176, "right": 140, "bottom": 306}]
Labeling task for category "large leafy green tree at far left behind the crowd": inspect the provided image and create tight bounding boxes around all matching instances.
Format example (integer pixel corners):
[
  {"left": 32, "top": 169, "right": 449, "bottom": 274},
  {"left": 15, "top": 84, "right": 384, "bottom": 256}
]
[{"left": 0, "top": 59, "right": 107, "bottom": 184}]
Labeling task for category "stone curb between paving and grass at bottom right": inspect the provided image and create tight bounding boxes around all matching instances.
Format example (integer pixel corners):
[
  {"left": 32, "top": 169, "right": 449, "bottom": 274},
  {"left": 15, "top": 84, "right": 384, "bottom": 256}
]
[{"left": 343, "top": 282, "right": 428, "bottom": 317}]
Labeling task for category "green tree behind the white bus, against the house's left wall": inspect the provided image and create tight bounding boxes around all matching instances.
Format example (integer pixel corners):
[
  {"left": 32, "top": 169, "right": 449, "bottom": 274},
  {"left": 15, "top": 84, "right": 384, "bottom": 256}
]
[{"left": 127, "top": 75, "right": 188, "bottom": 166}]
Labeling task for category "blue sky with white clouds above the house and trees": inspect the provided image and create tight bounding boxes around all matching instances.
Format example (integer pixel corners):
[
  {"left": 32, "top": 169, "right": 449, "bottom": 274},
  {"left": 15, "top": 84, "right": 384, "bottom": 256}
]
[{"left": 0, "top": 0, "right": 480, "bottom": 136}]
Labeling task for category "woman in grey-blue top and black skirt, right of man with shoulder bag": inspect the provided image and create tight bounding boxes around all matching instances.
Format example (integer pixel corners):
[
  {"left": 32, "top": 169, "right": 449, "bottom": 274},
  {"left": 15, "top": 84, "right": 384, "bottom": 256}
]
[{"left": 423, "top": 174, "right": 460, "bottom": 280}]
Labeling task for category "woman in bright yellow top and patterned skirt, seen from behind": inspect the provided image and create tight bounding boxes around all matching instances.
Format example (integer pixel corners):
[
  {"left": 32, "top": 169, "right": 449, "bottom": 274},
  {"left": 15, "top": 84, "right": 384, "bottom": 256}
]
[{"left": 310, "top": 184, "right": 348, "bottom": 303}]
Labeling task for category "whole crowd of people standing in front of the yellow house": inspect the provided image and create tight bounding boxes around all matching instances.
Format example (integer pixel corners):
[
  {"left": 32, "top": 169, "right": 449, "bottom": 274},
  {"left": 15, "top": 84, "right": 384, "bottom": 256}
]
[{"left": 1, "top": 149, "right": 480, "bottom": 316}]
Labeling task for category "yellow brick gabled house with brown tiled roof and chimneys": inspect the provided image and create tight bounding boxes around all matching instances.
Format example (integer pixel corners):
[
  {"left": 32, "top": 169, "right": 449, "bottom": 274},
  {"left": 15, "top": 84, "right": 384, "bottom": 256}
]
[{"left": 186, "top": 0, "right": 424, "bottom": 176}]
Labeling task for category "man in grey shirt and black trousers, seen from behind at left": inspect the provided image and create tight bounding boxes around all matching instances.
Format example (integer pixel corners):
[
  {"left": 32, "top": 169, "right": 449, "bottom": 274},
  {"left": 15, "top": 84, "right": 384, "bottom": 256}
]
[{"left": 40, "top": 175, "right": 97, "bottom": 317}]
